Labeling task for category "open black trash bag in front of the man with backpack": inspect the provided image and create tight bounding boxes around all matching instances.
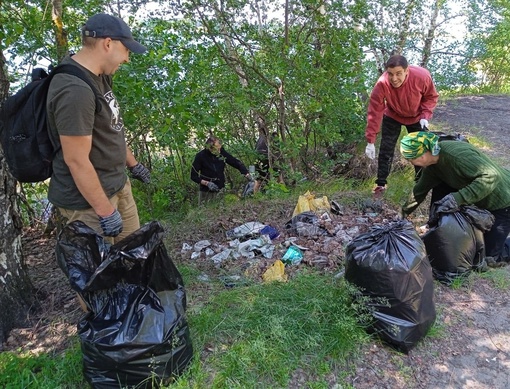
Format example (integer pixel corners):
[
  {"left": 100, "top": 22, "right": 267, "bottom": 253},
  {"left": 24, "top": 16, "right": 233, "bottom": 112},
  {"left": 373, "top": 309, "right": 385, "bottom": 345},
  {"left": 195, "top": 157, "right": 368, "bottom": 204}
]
[{"left": 56, "top": 221, "right": 193, "bottom": 389}]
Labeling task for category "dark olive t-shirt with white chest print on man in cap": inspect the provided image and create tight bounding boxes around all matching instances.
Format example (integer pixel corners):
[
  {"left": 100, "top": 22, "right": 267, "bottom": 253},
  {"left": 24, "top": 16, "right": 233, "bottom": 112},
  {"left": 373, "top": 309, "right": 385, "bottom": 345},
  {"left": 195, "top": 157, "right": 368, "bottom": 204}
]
[{"left": 46, "top": 58, "right": 127, "bottom": 210}]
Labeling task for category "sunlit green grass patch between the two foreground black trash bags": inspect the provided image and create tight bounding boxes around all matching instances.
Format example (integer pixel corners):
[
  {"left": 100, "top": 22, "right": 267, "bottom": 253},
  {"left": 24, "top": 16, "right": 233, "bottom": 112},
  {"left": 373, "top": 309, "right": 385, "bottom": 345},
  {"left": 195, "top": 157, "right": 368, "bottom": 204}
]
[{"left": 180, "top": 273, "right": 368, "bottom": 388}]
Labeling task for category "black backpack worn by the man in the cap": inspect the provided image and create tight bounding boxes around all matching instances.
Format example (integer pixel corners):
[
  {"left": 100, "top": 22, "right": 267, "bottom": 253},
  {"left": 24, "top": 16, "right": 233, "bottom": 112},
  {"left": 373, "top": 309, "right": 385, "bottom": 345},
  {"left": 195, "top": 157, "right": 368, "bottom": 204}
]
[{"left": 0, "top": 64, "right": 101, "bottom": 182}]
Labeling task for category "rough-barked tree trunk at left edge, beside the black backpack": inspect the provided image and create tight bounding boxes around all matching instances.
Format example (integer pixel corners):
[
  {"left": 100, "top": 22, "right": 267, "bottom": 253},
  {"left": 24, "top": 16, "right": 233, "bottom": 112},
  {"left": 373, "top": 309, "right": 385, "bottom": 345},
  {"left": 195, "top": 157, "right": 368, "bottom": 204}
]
[{"left": 0, "top": 50, "right": 35, "bottom": 343}]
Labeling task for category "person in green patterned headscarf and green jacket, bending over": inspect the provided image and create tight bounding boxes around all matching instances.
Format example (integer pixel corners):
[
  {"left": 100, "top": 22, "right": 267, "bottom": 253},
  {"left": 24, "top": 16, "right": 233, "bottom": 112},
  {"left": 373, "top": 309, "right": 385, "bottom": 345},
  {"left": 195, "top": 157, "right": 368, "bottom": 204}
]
[{"left": 400, "top": 131, "right": 510, "bottom": 263}]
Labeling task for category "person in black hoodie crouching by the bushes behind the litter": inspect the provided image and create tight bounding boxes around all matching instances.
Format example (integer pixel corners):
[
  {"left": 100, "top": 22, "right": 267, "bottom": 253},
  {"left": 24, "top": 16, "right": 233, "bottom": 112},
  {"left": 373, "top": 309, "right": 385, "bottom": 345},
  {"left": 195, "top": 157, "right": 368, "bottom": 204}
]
[{"left": 191, "top": 135, "right": 253, "bottom": 204}]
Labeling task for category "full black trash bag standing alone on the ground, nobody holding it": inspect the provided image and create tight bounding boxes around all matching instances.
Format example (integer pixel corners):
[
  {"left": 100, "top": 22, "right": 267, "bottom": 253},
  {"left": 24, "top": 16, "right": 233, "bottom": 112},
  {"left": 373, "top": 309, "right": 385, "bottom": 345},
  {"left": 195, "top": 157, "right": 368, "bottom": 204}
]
[{"left": 345, "top": 220, "right": 436, "bottom": 353}]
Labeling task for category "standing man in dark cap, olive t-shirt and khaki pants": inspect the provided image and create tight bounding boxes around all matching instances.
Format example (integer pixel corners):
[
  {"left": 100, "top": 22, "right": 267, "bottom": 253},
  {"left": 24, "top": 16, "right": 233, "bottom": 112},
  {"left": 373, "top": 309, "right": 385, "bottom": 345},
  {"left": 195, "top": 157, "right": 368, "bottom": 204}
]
[{"left": 47, "top": 14, "right": 150, "bottom": 242}]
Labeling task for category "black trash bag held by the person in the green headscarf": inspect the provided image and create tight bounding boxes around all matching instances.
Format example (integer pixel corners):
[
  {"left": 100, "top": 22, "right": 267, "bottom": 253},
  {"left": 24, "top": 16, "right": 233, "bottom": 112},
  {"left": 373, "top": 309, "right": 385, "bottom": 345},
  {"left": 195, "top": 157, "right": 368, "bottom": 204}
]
[{"left": 422, "top": 205, "right": 494, "bottom": 285}]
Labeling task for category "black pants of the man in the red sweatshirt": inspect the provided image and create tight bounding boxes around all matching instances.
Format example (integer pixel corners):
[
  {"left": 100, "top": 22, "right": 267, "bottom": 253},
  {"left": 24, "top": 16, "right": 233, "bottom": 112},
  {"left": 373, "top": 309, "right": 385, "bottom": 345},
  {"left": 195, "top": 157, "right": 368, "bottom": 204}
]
[{"left": 375, "top": 116, "right": 422, "bottom": 186}]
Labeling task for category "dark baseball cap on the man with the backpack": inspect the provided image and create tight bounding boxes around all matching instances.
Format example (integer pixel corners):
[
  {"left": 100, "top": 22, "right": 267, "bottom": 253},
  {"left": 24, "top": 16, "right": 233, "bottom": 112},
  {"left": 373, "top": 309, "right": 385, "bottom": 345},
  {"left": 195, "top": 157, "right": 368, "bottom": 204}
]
[{"left": 82, "top": 14, "right": 147, "bottom": 54}]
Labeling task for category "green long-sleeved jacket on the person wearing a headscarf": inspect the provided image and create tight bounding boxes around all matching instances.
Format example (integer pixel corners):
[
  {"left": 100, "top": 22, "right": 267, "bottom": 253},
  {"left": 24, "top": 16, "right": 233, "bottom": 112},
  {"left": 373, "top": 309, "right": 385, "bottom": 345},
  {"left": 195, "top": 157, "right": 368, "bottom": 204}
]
[{"left": 404, "top": 141, "right": 510, "bottom": 214}]
